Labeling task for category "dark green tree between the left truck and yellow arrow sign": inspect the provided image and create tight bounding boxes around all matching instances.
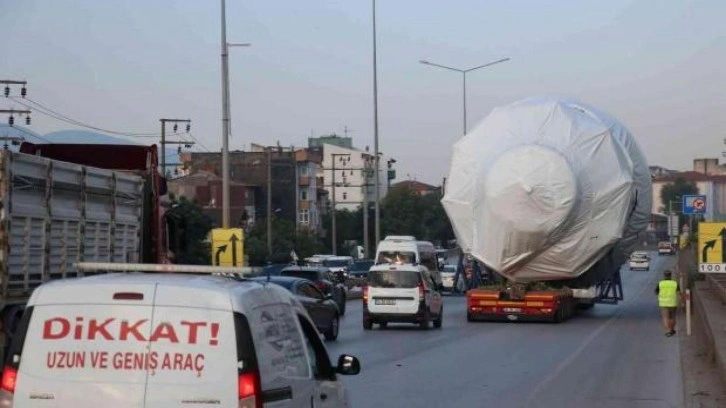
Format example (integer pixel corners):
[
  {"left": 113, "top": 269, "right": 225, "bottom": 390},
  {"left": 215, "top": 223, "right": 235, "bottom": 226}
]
[{"left": 167, "top": 197, "right": 212, "bottom": 265}]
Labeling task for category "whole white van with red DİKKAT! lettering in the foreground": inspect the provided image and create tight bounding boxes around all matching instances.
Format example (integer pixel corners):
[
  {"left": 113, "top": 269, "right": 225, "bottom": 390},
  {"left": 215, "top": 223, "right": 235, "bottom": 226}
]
[{"left": 0, "top": 265, "right": 360, "bottom": 408}]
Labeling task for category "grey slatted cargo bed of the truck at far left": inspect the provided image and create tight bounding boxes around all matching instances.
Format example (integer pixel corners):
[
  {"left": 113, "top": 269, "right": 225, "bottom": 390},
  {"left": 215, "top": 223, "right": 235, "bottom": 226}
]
[{"left": 0, "top": 150, "right": 144, "bottom": 304}]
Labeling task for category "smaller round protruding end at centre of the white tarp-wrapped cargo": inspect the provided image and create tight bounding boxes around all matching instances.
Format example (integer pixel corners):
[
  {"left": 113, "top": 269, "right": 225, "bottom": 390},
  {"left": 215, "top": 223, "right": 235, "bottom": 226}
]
[{"left": 485, "top": 145, "right": 577, "bottom": 236}]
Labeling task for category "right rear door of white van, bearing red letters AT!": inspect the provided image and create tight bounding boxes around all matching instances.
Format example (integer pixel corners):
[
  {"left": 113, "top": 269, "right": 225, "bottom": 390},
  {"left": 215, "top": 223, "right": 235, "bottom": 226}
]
[{"left": 146, "top": 284, "right": 239, "bottom": 408}]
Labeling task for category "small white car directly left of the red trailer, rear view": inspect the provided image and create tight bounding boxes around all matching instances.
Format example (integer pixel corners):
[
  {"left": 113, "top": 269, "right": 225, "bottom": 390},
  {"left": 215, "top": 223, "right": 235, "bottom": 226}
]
[{"left": 363, "top": 264, "right": 444, "bottom": 330}]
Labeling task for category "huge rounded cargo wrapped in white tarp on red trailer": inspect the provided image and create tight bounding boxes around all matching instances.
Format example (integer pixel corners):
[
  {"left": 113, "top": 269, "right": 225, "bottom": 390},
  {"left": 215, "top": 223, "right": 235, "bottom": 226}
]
[{"left": 442, "top": 98, "right": 651, "bottom": 282}]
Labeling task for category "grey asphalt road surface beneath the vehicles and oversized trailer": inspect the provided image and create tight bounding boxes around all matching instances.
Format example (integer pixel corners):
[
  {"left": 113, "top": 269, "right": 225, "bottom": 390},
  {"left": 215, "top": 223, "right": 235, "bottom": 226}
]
[{"left": 327, "top": 254, "right": 684, "bottom": 408}]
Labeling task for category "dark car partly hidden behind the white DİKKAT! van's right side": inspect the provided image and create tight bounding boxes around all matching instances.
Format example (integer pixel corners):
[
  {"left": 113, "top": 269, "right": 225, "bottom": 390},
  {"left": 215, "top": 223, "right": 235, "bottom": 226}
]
[{"left": 254, "top": 276, "right": 340, "bottom": 340}]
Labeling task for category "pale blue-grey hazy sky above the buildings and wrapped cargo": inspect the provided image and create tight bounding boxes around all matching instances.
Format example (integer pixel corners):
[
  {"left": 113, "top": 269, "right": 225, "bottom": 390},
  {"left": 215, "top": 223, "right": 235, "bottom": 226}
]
[{"left": 0, "top": 0, "right": 726, "bottom": 184}]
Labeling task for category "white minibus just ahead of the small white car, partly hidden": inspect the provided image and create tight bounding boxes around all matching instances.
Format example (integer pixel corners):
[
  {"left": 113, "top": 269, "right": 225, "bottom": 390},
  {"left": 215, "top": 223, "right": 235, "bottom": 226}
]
[{"left": 376, "top": 235, "right": 443, "bottom": 289}]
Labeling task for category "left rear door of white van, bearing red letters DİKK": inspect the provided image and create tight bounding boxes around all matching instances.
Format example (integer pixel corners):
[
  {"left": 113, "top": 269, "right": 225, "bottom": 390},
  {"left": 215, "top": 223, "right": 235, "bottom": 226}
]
[{"left": 10, "top": 283, "right": 155, "bottom": 408}]
